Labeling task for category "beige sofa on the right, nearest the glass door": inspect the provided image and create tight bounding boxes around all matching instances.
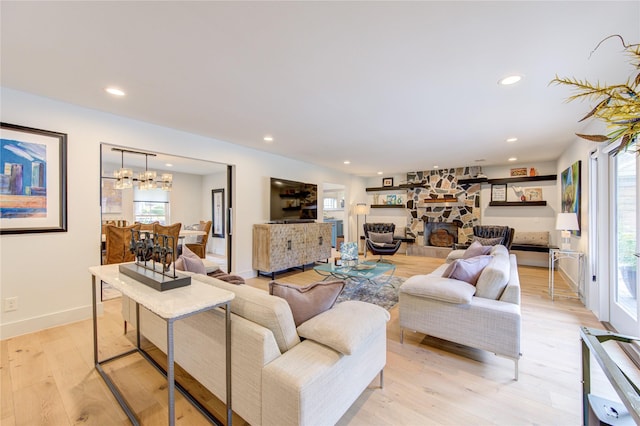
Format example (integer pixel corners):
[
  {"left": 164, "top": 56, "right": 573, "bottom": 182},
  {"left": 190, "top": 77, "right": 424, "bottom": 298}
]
[{"left": 399, "top": 246, "right": 521, "bottom": 380}]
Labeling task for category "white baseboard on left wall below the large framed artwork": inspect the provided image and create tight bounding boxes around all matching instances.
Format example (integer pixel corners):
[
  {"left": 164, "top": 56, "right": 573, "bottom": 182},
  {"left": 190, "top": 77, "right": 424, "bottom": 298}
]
[{"left": 0, "top": 302, "right": 104, "bottom": 340}]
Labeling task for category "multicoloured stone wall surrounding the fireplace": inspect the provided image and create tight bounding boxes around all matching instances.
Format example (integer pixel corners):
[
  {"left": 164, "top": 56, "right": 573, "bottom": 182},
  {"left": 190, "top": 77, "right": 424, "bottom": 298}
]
[{"left": 407, "top": 166, "right": 481, "bottom": 245}]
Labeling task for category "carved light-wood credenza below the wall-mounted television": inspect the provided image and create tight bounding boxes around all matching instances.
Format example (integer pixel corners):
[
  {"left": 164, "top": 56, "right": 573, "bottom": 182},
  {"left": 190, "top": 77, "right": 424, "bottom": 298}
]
[{"left": 253, "top": 223, "right": 332, "bottom": 277}]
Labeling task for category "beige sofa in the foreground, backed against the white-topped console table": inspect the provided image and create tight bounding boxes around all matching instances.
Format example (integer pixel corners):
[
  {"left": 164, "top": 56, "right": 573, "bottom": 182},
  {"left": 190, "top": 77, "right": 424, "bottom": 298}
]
[{"left": 123, "top": 275, "right": 389, "bottom": 426}]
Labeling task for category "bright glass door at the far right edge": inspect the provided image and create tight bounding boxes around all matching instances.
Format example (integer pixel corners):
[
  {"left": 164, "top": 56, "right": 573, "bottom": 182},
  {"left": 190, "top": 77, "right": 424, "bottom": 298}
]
[{"left": 609, "top": 146, "right": 640, "bottom": 336}]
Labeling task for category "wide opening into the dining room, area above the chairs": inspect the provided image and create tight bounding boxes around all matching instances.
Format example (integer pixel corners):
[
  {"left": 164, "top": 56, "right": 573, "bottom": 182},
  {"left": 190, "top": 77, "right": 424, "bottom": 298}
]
[{"left": 100, "top": 143, "right": 233, "bottom": 272}]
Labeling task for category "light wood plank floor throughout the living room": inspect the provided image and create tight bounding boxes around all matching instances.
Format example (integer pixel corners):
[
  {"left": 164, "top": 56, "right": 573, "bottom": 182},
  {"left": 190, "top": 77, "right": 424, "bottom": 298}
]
[{"left": 0, "top": 255, "right": 624, "bottom": 426}]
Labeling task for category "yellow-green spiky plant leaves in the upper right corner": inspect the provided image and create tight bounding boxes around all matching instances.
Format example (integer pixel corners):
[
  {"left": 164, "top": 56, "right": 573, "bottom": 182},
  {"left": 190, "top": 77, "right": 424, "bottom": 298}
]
[{"left": 551, "top": 34, "right": 640, "bottom": 154}]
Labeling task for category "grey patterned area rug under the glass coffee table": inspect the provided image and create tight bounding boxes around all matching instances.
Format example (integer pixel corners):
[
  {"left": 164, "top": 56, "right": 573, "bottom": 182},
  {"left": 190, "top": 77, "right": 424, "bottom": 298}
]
[{"left": 336, "top": 275, "right": 405, "bottom": 310}]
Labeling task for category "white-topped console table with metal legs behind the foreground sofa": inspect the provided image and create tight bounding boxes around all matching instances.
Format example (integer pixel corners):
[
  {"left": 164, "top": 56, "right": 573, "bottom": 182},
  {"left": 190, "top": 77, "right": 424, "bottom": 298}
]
[{"left": 89, "top": 264, "right": 235, "bottom": 426}]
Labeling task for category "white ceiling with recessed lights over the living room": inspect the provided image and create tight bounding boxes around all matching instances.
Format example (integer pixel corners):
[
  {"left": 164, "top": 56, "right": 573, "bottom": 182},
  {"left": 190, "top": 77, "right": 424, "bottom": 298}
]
[{"left": 0, "top": 1, "right": 640, "bottom": 176}]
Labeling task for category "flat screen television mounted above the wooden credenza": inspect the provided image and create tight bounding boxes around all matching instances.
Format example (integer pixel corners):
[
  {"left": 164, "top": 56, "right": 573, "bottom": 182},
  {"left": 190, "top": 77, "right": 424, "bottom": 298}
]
[{"left": 269, "top": 178, "right": 318, "bottom": 223}]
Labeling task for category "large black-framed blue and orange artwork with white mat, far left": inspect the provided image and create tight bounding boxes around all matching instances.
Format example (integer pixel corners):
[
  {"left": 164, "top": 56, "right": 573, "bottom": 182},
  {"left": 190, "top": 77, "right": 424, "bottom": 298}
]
[{"left": 0, "top": 123, "right": 67, "bottom": 234}]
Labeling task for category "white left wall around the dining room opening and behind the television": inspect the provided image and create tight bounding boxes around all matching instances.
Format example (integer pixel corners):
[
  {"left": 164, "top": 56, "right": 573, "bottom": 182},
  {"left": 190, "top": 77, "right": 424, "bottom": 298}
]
[{"left": 0, "top": 88, "right": 363, "bottom": 339}]
